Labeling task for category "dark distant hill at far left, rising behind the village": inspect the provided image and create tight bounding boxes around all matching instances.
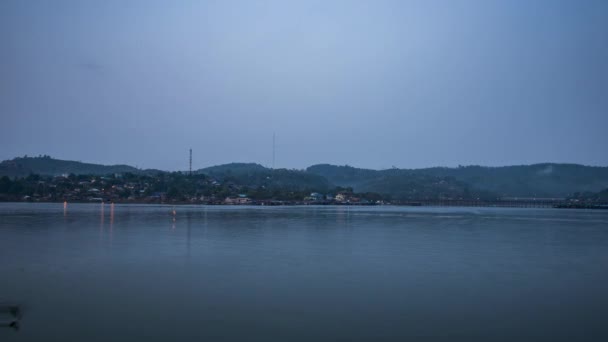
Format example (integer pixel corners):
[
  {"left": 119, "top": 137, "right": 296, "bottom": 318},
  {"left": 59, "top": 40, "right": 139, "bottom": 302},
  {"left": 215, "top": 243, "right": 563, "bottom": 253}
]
[{"left": 0, "top": 156, "right": 142, "bottom": 177}]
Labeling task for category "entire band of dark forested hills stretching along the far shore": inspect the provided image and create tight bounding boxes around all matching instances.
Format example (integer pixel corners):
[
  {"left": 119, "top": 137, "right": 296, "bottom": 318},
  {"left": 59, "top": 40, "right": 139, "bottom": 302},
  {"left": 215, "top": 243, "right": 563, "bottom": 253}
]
[{"left": 0, "top": 156, "right": 608, "bottom": 201}]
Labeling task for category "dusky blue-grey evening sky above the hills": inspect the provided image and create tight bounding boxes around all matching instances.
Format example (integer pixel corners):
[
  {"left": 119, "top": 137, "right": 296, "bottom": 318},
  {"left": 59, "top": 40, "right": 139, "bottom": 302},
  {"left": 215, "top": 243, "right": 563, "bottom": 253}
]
[{"left": 0, "top": 0, "right": 608, "bottom": 170}]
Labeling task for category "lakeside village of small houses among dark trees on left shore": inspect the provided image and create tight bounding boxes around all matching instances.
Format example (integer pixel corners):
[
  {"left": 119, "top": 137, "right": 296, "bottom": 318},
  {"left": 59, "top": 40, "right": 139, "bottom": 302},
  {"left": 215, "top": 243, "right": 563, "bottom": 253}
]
[{"left": 0, "top": 173, "right": 388, "bottom": 205}]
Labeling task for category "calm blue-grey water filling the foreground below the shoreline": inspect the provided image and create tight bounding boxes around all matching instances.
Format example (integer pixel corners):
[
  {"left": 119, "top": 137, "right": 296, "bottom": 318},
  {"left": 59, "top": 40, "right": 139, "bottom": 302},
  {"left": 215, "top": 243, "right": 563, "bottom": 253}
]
[{"left": 0, "top": 204, "right": 608, "bottom": 341}]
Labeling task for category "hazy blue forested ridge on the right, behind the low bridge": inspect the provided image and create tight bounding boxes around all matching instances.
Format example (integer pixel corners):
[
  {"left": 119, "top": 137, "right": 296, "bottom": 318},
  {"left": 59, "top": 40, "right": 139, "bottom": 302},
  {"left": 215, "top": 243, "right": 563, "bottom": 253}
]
[{"left": 307, "top": 163, "right": 608, "bottom": 197}]
